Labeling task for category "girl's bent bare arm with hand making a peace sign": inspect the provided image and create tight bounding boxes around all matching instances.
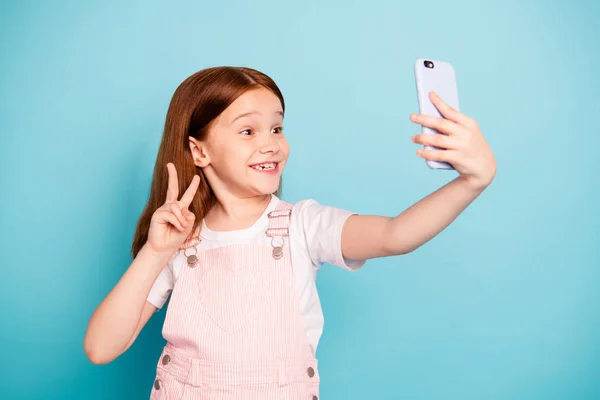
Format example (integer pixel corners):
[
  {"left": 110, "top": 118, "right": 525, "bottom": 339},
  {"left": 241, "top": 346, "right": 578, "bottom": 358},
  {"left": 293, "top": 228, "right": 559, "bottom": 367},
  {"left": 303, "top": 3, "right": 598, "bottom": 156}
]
[{"left": 83, "top": 163, "right": 199, "bottom": 364}]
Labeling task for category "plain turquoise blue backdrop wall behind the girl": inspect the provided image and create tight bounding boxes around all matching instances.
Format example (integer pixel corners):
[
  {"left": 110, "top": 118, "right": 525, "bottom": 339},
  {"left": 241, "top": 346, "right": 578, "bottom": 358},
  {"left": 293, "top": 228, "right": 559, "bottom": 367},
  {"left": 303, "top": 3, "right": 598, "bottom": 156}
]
[{"left": 0, "top": 0, "right": 600, "bottom": 400}]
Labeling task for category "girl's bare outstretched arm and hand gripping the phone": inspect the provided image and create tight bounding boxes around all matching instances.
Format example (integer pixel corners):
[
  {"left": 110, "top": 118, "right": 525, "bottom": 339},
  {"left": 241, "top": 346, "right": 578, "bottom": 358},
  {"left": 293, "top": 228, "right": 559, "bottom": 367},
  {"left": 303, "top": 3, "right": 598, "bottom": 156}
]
[{"left": 342, "top": 93, "right": 496, "bottom": 260}]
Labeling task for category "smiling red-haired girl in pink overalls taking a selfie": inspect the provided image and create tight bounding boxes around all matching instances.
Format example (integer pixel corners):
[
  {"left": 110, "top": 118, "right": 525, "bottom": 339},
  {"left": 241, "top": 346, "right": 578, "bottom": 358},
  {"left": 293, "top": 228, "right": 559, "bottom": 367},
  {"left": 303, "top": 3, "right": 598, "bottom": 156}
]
[{"left": 84, "top": 67, "right": 496, "bottom": 400}]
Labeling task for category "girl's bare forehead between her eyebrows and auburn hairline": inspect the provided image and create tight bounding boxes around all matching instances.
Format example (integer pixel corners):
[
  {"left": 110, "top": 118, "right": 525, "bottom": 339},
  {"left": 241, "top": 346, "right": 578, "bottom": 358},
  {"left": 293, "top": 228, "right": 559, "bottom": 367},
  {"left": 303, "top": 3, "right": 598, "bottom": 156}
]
[{"left": 218, "top": 88, "right": 283, "bottom": 125}]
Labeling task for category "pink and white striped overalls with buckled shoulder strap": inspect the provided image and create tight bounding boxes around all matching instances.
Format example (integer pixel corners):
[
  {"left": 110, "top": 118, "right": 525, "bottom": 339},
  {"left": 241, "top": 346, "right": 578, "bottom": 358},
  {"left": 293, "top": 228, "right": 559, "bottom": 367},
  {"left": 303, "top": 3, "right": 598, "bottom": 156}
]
[{"left": 150, "top": 201, "right": 320, "bottom": 400}]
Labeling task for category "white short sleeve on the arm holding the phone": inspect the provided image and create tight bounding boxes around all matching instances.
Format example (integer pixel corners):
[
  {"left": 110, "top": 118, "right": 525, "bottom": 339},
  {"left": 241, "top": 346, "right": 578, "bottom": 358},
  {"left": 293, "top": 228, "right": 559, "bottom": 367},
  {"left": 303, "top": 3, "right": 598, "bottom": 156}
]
[{"left": 291, "top": 200, "right": 365, "bottom": 271}]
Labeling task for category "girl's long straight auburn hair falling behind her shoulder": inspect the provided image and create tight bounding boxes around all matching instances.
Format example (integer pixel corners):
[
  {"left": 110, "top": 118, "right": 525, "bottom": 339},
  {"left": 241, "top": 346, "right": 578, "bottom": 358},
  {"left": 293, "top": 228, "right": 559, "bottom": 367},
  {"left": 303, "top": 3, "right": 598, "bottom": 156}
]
[{"left": 131, "top": 66, "right": 285, "bottom": 258}]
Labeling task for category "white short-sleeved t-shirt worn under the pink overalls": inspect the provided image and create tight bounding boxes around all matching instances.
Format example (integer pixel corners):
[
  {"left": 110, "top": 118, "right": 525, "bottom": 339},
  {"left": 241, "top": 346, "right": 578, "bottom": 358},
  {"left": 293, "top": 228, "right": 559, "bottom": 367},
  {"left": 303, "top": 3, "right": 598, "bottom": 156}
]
[{"left": 147, "top": 195, "right": 365, "bottom": 353}]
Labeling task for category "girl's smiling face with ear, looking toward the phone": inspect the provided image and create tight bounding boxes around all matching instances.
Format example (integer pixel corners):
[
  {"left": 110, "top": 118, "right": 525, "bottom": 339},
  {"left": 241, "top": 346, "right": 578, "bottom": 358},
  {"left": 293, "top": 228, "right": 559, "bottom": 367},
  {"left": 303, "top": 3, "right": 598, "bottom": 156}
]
[{"left": 190, "top": 88, "right": 290, "bottom": 198}]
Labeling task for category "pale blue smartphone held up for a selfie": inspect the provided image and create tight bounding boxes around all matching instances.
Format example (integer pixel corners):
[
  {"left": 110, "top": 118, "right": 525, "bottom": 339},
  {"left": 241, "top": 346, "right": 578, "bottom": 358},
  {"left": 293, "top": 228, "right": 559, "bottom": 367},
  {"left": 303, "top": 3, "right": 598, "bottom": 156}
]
[{"left": 415, "top": 58, "right": 460, "bottom": 170}]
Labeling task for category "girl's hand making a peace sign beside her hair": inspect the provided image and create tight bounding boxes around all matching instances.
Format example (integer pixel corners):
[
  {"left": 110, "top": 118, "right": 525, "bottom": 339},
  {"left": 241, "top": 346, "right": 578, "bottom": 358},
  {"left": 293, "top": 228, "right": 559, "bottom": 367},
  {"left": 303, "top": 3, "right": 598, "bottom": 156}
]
[{"left": 148, "top": 163, "right": 200, "bottom": 253}]
